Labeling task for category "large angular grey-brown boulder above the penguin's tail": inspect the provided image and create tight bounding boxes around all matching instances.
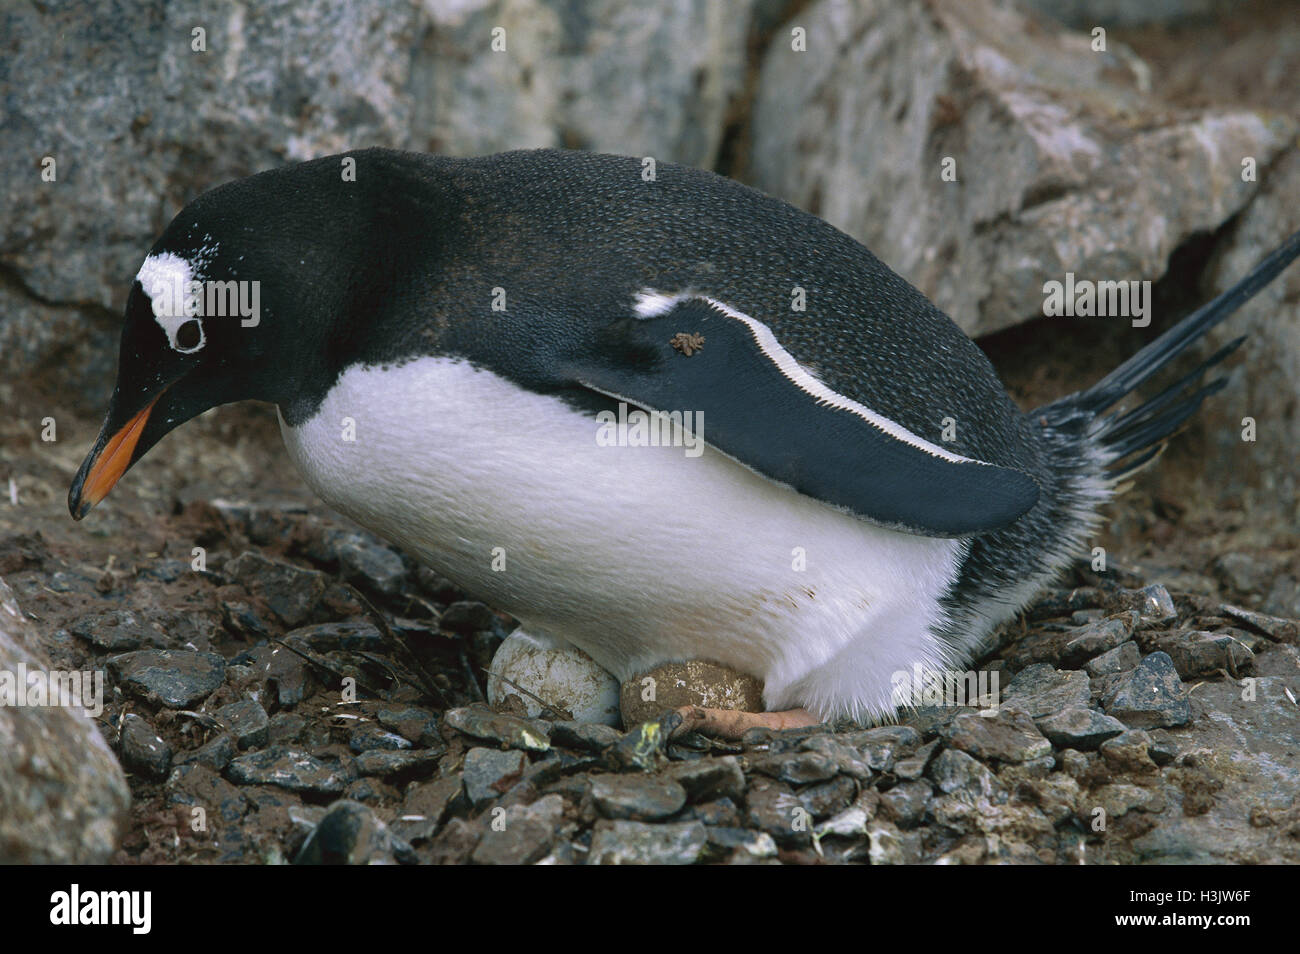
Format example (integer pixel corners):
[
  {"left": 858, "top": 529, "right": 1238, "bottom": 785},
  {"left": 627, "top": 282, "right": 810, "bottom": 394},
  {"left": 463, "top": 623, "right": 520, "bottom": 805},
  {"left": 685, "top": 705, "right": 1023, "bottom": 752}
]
[{"left": 753, "top": 0, "right": 1294, "bottom": 334}]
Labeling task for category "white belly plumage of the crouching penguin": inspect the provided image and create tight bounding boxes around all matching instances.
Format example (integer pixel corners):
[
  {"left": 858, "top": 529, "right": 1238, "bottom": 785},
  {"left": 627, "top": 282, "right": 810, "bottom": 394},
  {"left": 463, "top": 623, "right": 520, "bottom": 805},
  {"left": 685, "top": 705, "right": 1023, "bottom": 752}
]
[{"left": 281, "top": 357, "right": 962, "bottom": 717}]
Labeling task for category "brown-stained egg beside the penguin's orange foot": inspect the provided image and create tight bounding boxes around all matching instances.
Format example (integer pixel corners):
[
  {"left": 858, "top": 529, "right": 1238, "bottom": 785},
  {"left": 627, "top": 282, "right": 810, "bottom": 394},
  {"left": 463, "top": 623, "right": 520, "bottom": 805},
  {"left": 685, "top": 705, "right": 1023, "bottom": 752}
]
[{"left": 619, "top": 659, "right": 763, "bottom": 727}]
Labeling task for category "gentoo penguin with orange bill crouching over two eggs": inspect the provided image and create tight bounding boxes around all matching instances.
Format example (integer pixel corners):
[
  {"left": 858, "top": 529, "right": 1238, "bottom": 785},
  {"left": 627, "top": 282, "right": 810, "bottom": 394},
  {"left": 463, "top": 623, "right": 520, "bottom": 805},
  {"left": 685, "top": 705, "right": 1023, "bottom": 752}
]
[{"left": 69, "top": 149, "right": 1300, "bottom": 732}]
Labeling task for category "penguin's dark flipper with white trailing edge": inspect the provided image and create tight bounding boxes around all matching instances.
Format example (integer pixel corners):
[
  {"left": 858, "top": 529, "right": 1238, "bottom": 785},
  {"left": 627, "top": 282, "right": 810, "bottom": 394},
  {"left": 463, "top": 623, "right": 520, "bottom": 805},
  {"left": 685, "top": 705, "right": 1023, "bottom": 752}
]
[{"left": 568, "top": 296, "right": 1039, "bottom": 537}]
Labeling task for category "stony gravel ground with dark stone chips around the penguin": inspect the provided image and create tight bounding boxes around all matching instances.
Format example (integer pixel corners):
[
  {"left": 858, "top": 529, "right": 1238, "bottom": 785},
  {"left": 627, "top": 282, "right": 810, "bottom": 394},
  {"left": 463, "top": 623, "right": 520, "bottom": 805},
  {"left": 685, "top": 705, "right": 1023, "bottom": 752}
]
[{"left": 0, "top": 393, "right": 1300, "bottom": 864}]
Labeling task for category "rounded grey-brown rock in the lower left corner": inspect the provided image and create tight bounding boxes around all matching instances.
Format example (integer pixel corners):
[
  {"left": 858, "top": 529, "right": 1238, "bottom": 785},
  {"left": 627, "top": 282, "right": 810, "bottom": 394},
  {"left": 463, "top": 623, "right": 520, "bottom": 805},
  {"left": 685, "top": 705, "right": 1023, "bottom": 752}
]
[{"left": 0, "top": 580, "right": 130, "bottom": 864}]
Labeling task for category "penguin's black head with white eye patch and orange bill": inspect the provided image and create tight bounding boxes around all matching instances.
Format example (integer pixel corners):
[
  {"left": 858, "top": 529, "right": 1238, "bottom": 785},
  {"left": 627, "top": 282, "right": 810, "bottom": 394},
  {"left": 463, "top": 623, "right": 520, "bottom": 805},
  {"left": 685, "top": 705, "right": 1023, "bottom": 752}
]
[{"left": 68, "top": 164, "right": 366, "bottom": 520}]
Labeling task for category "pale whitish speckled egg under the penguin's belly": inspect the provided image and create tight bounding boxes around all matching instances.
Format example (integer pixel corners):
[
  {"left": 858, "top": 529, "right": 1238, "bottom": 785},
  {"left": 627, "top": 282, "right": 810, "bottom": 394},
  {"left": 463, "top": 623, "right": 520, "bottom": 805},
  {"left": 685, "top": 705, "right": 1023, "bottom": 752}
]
[{"left": 491, "top": 631, "right": 624, "bottom": 725}]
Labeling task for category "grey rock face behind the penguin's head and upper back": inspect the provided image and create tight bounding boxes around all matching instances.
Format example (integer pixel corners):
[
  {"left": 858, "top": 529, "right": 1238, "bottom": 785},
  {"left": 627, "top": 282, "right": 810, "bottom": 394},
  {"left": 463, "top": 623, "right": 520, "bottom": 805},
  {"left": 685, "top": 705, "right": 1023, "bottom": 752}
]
[{"left": 0, "top": 0, "right": 751, "bottom": 404}]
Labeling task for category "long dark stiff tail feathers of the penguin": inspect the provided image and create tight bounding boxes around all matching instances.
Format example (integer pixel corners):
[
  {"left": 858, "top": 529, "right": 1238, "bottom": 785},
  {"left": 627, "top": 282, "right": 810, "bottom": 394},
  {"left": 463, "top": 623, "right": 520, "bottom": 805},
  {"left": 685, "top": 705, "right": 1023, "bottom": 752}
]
[{"left": 1034, "top": 231, "right": 1300, "bottom": 486}]
